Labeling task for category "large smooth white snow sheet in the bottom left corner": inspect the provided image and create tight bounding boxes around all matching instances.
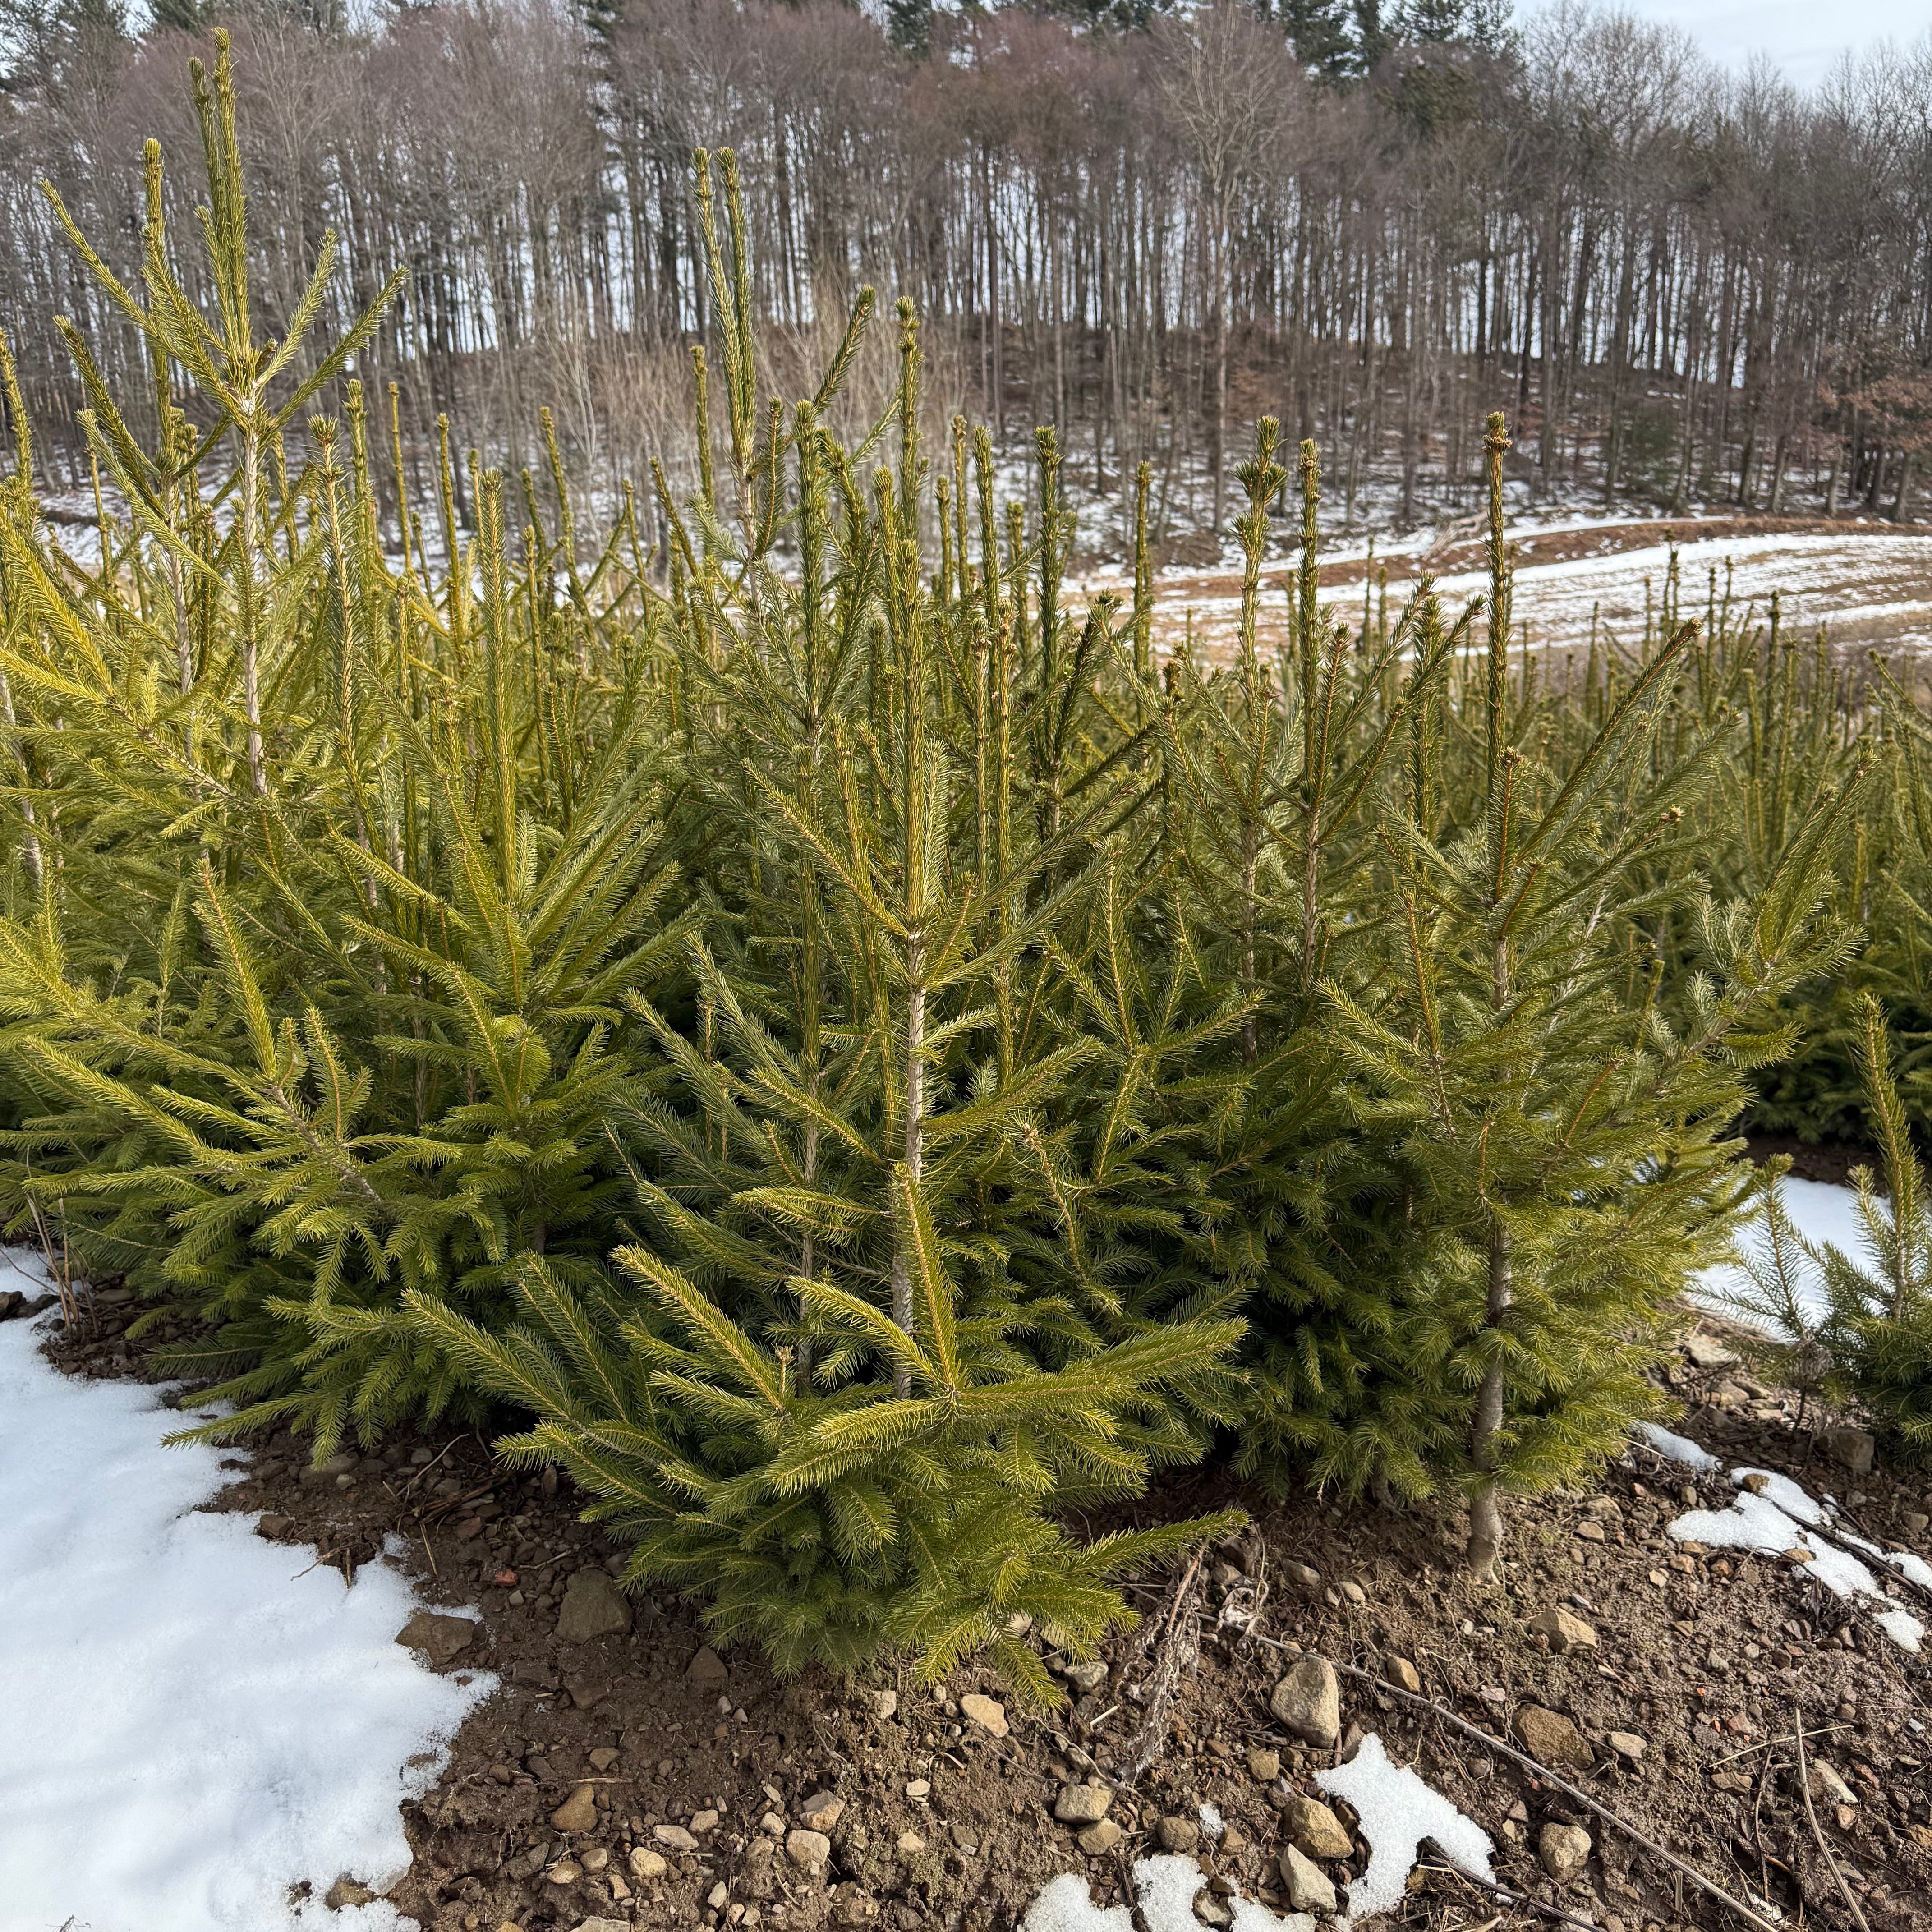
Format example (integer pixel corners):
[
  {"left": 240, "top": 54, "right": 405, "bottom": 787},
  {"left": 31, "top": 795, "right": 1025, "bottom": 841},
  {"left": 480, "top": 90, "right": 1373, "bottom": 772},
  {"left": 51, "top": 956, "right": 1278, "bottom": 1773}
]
[{"left": 0, "top": 1252, "right": 495, "bottom": 1932}]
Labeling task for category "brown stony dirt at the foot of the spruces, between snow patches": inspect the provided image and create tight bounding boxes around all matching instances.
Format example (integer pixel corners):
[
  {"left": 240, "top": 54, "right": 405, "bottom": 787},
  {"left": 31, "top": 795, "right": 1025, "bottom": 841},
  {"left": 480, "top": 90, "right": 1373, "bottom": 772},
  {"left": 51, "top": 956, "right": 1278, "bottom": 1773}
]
[{"left": 15, "top": 1310, "right": 1932, "bottom": 1932}]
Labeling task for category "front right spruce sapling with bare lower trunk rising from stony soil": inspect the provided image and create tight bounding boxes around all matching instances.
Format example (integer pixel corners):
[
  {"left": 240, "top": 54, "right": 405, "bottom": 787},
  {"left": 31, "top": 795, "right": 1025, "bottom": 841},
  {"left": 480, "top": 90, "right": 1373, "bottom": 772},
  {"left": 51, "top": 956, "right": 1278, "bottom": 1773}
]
[{"left": 1331, "top": 417, "right": 1845, "bottom": 1577}]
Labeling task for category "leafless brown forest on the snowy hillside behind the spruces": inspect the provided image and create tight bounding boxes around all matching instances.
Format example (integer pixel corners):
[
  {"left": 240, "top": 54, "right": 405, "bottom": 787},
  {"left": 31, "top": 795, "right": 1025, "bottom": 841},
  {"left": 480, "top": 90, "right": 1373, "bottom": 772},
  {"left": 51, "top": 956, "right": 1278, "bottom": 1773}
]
[{"left": 11, "top": 0, "right": 1932, "bottom": 552}]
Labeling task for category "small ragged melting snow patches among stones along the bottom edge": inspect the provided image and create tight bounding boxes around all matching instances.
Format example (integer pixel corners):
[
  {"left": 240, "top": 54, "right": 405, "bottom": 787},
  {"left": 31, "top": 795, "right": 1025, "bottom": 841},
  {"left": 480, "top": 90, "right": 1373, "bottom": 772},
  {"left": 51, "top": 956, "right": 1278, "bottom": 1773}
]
[{"left": 1020, "top": 1733, "right": 1495, "bottom": 1932}]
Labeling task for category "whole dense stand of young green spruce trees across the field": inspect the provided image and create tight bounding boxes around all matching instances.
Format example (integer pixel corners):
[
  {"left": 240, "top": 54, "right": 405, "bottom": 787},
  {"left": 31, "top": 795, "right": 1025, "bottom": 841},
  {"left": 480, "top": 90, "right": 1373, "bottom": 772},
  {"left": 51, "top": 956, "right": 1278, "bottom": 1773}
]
[{"left": 0, "top": 34, "right": 1932, "bottom": 1700}]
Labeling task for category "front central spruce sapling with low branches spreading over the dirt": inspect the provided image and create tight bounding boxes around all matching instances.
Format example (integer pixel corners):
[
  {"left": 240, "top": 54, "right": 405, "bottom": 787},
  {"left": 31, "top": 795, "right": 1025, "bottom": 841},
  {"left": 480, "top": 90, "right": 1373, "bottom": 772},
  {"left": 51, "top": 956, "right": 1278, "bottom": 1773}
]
[{"left": 414, "top": 276, "right": 1237, "bottom": 1698}]
